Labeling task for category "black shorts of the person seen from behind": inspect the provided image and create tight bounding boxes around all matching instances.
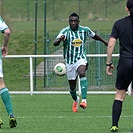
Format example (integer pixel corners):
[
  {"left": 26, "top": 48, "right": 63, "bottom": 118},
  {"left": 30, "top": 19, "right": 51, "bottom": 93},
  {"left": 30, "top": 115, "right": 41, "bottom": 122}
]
[{"left": 115, "top": 58, "right": 133, "bottom": 91}]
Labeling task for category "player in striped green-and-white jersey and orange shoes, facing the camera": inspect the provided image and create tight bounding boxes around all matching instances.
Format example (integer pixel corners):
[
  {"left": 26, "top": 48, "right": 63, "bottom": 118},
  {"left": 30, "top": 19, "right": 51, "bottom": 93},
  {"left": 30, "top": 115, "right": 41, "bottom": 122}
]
[{"left": 54, "top": 13, "right": 108, "bottom": 112}]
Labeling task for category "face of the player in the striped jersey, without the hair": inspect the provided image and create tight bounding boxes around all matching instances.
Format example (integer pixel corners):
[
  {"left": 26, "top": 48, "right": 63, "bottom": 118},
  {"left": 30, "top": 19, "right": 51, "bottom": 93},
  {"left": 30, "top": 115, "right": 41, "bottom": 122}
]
[{"left": 68, "top": 17, "right": 80, "bottom": 31}]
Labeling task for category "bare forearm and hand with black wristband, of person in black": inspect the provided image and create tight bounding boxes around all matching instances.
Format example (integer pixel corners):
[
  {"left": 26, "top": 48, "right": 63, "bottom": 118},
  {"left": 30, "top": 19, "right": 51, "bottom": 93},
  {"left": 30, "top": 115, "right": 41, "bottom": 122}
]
[{"left": 106, "top": 38, "right": 116, "bottom": 76}]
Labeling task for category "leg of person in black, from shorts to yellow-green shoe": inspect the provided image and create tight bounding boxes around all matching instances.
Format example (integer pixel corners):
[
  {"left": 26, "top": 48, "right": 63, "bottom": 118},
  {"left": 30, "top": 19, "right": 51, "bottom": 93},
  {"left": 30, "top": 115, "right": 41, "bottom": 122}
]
[{"left": 111, "top": 58, "right": 132, "bottom": 132}]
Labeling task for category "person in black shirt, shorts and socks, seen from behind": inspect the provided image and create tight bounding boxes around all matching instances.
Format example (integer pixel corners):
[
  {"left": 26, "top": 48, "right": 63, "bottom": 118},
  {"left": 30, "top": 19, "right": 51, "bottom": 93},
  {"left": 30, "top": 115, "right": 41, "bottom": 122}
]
[{"left": 106, "top": 0, "right": 133, "bottom": 132}]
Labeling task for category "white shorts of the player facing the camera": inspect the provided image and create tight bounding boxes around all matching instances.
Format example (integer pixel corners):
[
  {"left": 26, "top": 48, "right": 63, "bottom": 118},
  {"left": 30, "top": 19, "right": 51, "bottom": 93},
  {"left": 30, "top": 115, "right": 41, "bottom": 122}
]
[{"left": 66, "top": 59, "right": 87, "bottom": 80}]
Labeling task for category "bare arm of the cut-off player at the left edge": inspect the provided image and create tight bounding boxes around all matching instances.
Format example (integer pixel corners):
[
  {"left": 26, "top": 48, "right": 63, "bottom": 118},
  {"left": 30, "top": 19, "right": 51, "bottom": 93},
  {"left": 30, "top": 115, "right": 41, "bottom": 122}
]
[{"left": 1, "top": 28, "right": 10, "bottom": 57}]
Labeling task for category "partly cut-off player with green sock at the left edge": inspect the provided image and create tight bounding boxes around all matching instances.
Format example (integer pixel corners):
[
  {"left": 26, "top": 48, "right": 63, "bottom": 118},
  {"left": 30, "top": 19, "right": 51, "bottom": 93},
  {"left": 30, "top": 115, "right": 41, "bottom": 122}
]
[{"left": 0, "top": 16, "right": 17, "bottom": 128}]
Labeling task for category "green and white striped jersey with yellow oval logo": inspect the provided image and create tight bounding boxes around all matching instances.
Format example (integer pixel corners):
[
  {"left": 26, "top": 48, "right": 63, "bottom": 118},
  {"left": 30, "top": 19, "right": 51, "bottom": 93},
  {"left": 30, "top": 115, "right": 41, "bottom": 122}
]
[{"left": 57, "top": 25, "right": 95, "bottom": 64}]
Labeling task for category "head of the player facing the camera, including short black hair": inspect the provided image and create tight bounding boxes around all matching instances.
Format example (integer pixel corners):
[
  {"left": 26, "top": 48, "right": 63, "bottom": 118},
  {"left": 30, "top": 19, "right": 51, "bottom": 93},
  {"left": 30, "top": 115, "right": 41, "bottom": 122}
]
[{"left": 68, "top": 12, "right": 80, "bottom": 31}]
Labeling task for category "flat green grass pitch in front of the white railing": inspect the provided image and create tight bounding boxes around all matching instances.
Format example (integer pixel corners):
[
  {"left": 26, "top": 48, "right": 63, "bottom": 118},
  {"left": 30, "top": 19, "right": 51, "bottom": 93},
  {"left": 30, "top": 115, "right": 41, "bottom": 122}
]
[{"left": 0, "top": 95, "right": 132, "bottom": 133}]
